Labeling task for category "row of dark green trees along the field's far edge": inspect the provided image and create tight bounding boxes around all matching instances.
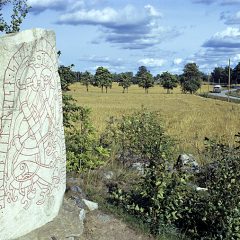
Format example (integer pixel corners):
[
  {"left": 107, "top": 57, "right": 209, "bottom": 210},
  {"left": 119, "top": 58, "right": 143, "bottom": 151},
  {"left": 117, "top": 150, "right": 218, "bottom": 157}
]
[{"left": 59, "top": 62, "right": 240, "bottom": 94}]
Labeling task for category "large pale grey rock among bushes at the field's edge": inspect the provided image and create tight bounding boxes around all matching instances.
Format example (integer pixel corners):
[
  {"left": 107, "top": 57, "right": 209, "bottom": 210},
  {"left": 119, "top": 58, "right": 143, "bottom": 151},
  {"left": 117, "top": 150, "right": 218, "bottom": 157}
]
[{"left": 174, "top": 154, "right": 199, "bottom": 173}]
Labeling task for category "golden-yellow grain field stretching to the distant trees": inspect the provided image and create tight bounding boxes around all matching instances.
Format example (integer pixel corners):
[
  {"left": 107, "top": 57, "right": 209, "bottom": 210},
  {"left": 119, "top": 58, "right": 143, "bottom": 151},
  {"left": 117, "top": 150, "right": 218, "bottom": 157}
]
[{"left": 70, "top": 83, "right": 240, "bottom": 161}]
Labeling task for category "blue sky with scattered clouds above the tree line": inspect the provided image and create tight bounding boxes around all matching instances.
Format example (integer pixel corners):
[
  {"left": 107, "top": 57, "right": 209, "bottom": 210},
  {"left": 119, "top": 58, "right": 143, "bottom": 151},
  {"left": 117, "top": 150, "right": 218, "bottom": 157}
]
[{"left": 3, "top": 0, "right": 240, "bottom": 75}]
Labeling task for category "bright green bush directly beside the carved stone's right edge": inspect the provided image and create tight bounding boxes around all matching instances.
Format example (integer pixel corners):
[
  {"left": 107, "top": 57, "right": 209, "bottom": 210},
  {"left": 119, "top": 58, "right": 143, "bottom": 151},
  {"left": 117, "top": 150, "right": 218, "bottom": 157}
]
[{"left": 63, "top": 95, "right": 109, "bottom": 172}]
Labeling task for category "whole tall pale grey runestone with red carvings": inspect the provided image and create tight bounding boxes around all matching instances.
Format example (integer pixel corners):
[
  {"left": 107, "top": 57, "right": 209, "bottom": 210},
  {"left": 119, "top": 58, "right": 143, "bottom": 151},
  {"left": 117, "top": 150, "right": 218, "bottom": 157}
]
[{"left": 0, "top": 29, "right": 66, "bottom": 240}]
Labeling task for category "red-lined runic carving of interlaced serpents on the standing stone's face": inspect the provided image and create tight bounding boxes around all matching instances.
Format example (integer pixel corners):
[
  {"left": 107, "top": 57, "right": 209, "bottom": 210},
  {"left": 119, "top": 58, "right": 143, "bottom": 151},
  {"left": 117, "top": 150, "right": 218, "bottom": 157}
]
[{"left": 0, "top": 38, "right": 65, "bottom": 209}]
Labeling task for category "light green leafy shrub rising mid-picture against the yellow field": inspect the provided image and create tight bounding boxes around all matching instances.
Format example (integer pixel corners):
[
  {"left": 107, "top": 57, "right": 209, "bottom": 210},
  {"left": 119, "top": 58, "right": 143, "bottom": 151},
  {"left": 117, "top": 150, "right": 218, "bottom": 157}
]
[{"left": 101, "top": 109, "right": 173, "bottom": 165}]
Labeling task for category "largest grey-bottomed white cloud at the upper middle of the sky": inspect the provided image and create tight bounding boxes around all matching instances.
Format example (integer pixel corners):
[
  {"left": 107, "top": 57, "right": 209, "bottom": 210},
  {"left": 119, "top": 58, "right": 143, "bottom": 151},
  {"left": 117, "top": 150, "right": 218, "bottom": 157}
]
[{"left": 57, "top": 5, "right": 180, "bottom": 49}]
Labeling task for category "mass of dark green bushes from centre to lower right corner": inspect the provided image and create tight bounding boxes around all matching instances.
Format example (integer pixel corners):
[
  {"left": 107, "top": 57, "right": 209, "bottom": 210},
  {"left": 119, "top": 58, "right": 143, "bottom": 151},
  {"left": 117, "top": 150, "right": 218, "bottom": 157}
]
[{"left": 109, "top": 113, "right": 240, "bottom": 240}]
